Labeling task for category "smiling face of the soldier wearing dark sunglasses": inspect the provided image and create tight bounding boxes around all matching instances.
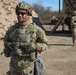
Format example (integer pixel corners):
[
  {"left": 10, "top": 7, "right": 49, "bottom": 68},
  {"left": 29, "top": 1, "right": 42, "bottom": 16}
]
[{"left": 16, "top": 10, "right": 29, "bottom": 23}]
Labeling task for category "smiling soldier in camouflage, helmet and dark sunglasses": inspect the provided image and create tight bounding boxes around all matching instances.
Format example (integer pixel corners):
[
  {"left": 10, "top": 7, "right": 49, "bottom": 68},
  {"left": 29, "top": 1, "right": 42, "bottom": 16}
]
[{"left": 4, "top": 2, "right": 48, "bottom": 75}]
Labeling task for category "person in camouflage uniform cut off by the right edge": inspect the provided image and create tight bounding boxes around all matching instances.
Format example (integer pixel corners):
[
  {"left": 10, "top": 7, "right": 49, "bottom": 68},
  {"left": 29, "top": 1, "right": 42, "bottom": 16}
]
[{"left": 71, "top": 11, "right": 76, "bottom": 46}]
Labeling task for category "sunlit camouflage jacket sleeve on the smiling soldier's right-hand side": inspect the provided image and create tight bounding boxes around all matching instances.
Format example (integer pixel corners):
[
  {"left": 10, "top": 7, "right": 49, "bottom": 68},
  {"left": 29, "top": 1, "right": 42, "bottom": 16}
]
[{"left": 36, "top": 24, "right": 48, "bottom": 51}]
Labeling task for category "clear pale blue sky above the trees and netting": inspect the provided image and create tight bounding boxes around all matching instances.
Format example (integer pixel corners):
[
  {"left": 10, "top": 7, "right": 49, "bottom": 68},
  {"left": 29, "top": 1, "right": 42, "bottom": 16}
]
[{"left": 19, "top": 0, "right": 62, "bottom": 11}]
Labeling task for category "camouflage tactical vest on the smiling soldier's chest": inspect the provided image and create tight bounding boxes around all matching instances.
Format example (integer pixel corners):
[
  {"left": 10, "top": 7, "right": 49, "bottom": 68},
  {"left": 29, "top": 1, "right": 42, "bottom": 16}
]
[{"left": 10, "top": 24, "right": 36, "bottom": 56}]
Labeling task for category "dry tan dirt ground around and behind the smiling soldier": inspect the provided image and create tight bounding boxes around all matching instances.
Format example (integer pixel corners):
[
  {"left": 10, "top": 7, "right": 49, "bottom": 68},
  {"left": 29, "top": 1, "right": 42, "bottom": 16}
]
[{"left": 0, "top": 26, "right": 76, "bottom": 75}]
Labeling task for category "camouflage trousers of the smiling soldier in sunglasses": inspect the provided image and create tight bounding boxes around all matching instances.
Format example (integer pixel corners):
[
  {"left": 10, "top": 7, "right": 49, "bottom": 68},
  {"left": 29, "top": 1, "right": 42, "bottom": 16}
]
[{"left": 8, "top": 57, "right": 34, "bottom": 75}]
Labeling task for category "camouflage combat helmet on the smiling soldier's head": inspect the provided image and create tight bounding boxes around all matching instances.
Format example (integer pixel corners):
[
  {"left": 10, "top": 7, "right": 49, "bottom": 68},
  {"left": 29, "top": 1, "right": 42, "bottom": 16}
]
[{"left": 16, "top": 2, "right": 32, "bottom": 16}]
